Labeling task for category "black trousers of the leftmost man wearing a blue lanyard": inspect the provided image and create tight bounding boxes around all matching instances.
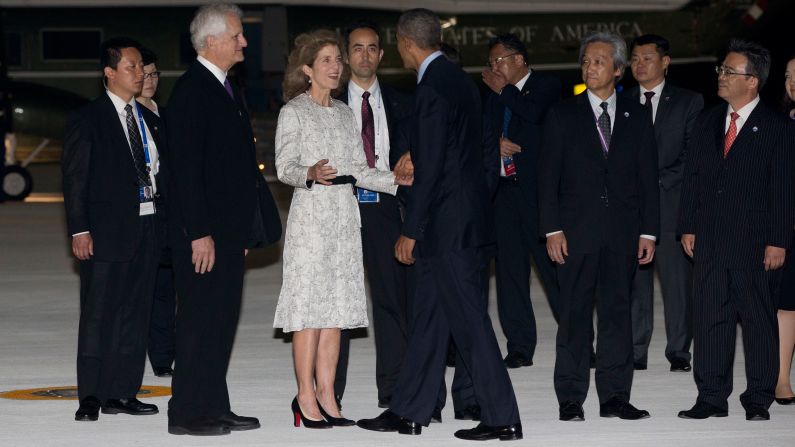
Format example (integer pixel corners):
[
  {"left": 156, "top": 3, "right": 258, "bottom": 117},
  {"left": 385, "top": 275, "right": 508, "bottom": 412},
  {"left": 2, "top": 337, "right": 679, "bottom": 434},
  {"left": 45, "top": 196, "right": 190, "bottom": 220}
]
[{"left": 77, "top": 216, "right": 159, "bottom": 403}]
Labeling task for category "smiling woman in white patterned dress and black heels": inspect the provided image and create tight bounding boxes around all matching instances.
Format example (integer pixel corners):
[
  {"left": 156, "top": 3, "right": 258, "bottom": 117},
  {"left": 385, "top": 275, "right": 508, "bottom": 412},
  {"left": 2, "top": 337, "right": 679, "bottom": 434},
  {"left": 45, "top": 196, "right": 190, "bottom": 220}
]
[{"left": 273, "top": 30, "right": 408, "bottom": 428}]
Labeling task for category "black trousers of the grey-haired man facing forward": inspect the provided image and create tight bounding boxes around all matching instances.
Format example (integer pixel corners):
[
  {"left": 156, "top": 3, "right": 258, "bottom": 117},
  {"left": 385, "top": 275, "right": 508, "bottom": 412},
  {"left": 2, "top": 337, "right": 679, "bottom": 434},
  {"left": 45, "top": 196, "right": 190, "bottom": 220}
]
[{"left": 554, "top": 248, "right": 638, "bottom": 404}]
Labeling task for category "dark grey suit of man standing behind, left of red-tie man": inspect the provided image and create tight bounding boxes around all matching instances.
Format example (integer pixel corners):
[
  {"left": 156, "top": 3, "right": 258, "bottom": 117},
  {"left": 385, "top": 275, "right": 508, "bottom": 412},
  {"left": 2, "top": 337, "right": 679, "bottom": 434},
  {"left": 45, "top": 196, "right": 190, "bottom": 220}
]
[{"left": 627, "top": 82, "right": 704, "bottom": 365}]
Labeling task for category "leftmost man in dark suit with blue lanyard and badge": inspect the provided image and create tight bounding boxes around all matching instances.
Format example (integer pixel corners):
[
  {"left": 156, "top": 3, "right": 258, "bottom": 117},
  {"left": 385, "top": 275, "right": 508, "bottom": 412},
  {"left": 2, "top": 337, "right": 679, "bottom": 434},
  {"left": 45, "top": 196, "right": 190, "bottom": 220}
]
[{"left": 63, "top": 37, "right": 165, "bottom": 421}]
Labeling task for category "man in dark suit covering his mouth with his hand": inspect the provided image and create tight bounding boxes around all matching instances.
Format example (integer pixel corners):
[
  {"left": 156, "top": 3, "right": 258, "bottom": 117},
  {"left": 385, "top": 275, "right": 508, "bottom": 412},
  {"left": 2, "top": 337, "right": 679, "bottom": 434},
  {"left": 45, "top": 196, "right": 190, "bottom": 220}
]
[{"left": 483, "top": 30, "right": 560, "bottom": 368}]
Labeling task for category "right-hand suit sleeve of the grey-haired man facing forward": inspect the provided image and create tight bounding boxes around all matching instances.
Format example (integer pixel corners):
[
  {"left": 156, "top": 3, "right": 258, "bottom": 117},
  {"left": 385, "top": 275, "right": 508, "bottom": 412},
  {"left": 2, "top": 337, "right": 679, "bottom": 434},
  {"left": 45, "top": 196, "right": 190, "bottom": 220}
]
[{"left": 638, "top": 118, "right": 660, "bottom": 239}]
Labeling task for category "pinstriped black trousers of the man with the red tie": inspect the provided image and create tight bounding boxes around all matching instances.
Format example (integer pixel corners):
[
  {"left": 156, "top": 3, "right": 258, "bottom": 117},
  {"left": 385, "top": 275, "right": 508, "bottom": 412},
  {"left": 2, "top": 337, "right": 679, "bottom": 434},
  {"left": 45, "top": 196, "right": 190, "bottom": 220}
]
[{"left": 693, "top": 260, "right": 781, "bottom": 410}]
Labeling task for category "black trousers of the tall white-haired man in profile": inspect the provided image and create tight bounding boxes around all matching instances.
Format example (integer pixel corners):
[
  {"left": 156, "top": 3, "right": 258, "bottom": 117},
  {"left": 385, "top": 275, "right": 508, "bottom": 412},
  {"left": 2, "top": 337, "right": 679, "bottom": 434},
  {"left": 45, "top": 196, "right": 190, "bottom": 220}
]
[{"left": 168, "top": 250, "right": 245, "bottom": 424}]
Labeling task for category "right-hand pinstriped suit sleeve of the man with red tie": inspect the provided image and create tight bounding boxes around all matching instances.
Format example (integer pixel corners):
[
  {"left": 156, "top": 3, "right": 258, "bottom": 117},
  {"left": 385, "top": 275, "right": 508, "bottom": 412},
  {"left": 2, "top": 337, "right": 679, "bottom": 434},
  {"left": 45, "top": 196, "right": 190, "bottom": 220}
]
[{"left": 765, "top": 122, "right": 795, "bottom": 248}]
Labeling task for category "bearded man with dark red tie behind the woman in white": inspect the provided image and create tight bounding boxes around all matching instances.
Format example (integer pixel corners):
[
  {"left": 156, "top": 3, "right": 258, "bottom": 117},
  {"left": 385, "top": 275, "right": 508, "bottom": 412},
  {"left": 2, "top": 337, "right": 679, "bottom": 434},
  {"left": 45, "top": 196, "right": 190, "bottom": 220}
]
[{"left": 334, "top": 21, "right": 410, "bottom": 408}]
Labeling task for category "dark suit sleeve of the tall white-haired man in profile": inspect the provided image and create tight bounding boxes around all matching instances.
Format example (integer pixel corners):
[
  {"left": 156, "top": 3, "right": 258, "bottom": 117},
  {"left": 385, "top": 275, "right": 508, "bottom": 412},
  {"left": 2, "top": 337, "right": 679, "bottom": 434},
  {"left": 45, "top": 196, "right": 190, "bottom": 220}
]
[{"left": 166, "top": 89, "right": 213, "bottom": 241}]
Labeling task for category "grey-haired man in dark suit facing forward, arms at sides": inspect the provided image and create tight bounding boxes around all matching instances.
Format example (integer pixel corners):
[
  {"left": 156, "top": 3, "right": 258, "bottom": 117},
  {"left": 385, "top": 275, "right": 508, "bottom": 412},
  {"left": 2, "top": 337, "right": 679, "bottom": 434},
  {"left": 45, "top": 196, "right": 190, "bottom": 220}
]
[{"left": 539, "top": 32, "right": 660, "bottom": 421}]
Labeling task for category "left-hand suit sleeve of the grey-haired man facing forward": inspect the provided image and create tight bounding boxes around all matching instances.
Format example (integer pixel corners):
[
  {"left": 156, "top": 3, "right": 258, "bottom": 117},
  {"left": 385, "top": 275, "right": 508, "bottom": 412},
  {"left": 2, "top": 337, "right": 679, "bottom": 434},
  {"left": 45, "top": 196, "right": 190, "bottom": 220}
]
[{"left": 538, "top": 108, "right": 565, "bottom": 237}]
